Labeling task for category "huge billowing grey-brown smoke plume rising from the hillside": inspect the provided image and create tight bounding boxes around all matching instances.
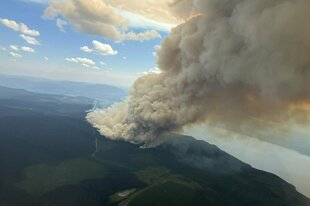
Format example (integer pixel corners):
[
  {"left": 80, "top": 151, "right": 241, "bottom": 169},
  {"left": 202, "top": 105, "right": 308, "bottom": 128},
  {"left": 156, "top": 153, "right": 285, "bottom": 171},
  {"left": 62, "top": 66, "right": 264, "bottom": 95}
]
[{"left": 87, "top": 0, "right": 310, "bottom": 144}]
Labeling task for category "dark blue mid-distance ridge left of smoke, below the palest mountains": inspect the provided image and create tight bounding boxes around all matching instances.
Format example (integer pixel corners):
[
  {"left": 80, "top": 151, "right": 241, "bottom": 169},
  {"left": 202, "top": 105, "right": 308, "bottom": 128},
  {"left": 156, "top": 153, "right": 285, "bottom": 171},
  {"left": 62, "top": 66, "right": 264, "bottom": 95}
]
[{"left": 0, "top": 86, "right": 94, "bottom": 118}]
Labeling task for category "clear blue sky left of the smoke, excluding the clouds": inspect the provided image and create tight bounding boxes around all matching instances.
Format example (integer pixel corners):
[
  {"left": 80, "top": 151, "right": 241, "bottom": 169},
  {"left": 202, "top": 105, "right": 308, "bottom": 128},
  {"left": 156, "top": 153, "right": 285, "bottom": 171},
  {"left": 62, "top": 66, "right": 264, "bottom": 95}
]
[{"left": 0, "top": 0, "right": 168, "bottom": 86}]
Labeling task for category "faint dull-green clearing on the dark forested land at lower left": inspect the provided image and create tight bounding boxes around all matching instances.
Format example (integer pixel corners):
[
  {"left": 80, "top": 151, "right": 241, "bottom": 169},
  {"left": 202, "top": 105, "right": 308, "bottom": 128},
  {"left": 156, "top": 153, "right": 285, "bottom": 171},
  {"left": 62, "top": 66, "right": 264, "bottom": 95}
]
[{"left": 16, "top": 158, "right": 106, "bottom": 196}]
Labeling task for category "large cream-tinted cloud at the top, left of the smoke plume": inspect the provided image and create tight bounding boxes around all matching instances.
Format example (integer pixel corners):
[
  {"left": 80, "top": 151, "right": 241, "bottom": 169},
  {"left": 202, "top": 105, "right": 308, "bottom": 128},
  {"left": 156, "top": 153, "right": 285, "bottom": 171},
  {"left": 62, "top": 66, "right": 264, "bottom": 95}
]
[{"left": 44, "top": 0, "right": 160, "bottom": 42}]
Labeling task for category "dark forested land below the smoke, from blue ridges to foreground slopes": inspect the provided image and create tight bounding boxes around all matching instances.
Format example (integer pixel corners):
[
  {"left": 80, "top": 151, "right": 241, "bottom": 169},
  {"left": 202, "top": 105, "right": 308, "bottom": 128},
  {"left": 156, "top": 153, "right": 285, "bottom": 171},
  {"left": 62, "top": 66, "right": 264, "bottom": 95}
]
[{"left": 0, "top": 87, "right": 310, "bottom": 206}]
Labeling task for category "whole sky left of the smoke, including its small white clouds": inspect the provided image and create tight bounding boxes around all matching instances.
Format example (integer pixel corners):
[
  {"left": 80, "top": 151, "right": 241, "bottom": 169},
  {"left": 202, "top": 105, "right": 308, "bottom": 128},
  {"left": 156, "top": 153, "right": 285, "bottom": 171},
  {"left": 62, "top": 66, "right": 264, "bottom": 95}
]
[{"left": 0, "top": 0, "right": 173, "bottom": 87}]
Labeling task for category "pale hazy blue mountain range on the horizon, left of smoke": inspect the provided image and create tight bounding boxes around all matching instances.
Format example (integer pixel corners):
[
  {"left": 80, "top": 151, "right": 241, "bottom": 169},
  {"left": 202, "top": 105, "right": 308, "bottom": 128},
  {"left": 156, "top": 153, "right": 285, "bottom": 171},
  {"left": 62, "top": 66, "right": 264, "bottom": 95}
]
[{"left": 0, "top": 75, "right": 127, "bottom": 102}]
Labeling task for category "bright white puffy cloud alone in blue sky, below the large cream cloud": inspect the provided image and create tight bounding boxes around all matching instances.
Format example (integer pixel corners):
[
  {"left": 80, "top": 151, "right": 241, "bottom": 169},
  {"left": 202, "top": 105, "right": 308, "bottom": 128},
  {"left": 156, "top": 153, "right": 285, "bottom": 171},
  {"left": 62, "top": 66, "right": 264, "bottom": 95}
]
[{"left": 80, "top": 40, "right": 118, "bottom": 56}]
